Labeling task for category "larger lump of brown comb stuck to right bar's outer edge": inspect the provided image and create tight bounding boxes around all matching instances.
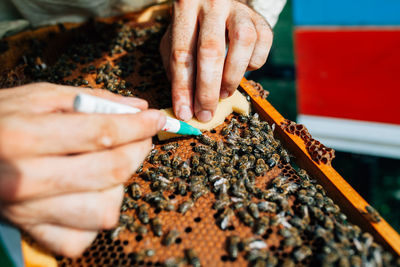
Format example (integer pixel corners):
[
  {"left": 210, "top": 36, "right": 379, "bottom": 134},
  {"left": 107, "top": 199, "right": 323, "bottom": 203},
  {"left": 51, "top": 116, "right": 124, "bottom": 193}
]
[{"left": 281, "top": 120, "right": 335, "bottom": 164}]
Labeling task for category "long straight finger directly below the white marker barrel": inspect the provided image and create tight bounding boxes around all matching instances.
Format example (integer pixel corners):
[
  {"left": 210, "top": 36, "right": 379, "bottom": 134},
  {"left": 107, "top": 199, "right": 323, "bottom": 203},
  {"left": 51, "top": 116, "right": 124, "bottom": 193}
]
[{"left": 0, "top": 110, "right": 166, "bottom": 158}]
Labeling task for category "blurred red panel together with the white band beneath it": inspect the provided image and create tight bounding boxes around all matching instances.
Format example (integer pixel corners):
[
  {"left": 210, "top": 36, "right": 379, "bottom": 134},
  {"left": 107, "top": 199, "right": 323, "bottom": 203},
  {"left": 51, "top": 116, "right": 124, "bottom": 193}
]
[{"left": 295, "top": 26, "right": 400, "bottom": 159}]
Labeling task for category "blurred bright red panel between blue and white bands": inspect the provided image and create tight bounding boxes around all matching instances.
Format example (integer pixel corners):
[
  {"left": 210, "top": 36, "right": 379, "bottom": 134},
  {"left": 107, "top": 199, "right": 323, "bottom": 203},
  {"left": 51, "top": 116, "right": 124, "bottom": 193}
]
[{"left": 295, "top": 27, "right": 400, "bottom": 124}]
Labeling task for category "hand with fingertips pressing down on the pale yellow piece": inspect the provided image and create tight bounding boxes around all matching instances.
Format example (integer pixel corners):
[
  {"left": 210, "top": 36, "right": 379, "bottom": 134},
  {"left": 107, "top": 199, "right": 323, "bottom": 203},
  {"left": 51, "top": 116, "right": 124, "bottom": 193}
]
[{"left": 160, "top": 0, "right": 273, "bottom": 121}]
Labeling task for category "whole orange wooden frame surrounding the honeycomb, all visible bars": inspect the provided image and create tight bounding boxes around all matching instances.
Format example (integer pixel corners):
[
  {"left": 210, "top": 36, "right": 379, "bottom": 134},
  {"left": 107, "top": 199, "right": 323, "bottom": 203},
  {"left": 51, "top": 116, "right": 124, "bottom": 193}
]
[{"left": 0, "top": 2, "right": 400, "bottom": 266}]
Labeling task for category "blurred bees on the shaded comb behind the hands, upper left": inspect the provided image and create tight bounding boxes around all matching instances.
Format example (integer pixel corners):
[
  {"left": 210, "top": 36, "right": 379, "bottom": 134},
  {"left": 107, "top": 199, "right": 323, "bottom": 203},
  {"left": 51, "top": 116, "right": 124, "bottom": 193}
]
[{"left": 21, "top": 18, "right": 169, "bottom": 100}]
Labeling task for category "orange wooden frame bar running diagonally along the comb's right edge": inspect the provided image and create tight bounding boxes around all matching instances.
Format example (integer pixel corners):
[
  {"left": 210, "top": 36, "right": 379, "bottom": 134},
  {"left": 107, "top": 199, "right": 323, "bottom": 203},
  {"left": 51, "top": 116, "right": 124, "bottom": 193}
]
[{"left": 240, "top": 78, "right": 400, "bottom": 256}]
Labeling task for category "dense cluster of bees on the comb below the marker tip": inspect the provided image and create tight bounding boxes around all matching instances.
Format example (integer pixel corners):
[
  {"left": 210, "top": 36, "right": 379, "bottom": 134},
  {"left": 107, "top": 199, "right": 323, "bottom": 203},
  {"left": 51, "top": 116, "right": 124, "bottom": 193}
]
[{"left": 113, "top": 113, "right": 400, "bottom": 266}]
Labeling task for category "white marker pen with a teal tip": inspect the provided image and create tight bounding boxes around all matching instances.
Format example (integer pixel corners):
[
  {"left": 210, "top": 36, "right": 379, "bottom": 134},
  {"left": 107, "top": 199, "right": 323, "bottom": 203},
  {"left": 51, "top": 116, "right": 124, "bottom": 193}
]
[{"left": 74, "top": 93, "right": 201, "bottom": 135}]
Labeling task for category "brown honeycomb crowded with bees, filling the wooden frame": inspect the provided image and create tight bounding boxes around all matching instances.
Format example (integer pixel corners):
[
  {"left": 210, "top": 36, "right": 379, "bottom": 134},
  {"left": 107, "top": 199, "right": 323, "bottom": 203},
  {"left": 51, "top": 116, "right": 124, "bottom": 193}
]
[{"left": 0, "top": 10, "right": 400, "bottom": 266}]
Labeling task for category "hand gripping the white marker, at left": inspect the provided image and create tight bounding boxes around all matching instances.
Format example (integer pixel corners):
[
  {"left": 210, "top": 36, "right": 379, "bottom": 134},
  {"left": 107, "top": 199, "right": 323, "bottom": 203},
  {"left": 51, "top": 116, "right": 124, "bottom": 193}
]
[{"left": 0, "top": 83, "right": 166, "bottom": 257}]
